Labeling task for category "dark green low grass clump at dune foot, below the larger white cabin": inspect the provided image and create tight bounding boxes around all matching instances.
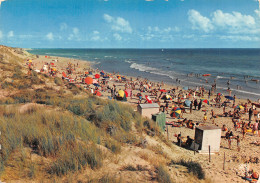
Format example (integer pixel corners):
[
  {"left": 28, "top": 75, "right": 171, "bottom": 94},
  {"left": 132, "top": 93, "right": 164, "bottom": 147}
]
[{"left": 170, "top": 159, "right": 205, "bottom": 179}]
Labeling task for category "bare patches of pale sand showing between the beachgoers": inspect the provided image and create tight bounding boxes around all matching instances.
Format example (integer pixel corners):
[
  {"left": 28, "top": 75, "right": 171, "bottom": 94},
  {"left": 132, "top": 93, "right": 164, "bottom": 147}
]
[{"left": 27, "top": 53, "right": 260, "bottom": 182}]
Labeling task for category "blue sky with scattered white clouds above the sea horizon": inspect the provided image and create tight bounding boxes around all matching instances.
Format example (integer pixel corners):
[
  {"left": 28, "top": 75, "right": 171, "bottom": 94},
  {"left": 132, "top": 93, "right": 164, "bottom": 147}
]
[{"left": 0, "top": 0, "right": 260, "bottom": 48}]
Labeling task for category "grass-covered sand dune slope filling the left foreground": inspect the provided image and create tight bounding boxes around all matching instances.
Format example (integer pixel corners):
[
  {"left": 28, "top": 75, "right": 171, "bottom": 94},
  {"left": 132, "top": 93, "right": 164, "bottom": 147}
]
[{"left": 0, "top": 47, "right": 210, "bottom": 182}]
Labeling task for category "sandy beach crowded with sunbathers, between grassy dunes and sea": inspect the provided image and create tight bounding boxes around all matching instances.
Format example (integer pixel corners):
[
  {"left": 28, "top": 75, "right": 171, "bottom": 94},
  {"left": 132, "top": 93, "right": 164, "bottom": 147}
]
[{"left": 24, "top": 55, "right": 260, "bottom": 182}]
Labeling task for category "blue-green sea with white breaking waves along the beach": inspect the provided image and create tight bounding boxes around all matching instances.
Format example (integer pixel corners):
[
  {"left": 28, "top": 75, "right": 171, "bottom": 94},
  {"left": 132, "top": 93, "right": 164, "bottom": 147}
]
[{"left": 29, "top": 48, "right": 260, "bottom": 101}]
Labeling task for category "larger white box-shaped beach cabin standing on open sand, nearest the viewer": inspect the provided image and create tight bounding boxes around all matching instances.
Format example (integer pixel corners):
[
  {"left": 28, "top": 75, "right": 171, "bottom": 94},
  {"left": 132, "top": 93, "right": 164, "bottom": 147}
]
[{"left": 195, "top": 126, "right": 221, "bottom": 153}]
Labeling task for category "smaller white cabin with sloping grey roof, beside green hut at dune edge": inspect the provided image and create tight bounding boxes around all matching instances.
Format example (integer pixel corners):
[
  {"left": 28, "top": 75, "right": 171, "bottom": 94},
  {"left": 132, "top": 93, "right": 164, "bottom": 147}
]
[{"left": 137, "top": 103, "right": 160, "bottom": 119}]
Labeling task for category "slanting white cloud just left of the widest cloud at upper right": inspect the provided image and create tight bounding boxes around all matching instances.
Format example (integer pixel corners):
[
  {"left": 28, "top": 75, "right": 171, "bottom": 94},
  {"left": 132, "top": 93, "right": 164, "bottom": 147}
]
[{"left": 188, "top": 9, "right": 214, "bottom": 32}]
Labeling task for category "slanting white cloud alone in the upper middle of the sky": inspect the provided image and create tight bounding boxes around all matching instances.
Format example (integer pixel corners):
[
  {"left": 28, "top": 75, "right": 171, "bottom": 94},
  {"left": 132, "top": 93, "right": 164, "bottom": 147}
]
[{"left": 103, "top": 14, "right": 133, "bottom": 33}]
